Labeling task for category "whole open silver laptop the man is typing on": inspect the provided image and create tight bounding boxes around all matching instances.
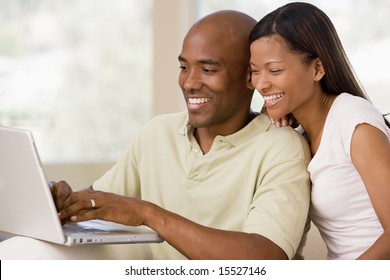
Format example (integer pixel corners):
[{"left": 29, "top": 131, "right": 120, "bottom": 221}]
[{"left": 0, "top": 126, "right": 163, "bottom": 246}]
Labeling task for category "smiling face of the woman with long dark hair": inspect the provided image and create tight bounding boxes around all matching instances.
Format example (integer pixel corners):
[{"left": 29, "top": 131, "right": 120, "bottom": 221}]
[{"left": 250, "top": 35, "right": 324, "bottom": 120}]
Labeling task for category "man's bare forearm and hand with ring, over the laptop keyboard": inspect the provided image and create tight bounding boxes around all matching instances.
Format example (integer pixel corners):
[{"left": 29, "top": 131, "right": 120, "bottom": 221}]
[{"left": 60, "top": 191, "right": 287, "bottom": 259}]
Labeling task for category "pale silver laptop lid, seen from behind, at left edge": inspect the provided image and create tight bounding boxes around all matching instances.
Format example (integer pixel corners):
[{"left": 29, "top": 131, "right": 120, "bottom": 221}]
[{"left": 0, "top": 127, "right": 65, "bottom": 244}]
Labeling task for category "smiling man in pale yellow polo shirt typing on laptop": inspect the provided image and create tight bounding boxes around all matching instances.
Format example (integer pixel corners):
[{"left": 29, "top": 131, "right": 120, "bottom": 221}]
[{"left": 53, "top": 11, "right": 310, "bottom": 259}]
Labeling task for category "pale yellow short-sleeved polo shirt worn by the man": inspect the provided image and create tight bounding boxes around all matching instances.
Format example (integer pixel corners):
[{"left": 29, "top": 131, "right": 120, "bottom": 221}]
[{"left": 93, "top": 112, "right": 310, "bottom": 259}]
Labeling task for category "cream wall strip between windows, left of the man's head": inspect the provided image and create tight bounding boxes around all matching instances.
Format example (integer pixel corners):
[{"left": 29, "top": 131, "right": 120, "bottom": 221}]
[{"left": 153, "top": 0, "right": 196, "bottom": 115}]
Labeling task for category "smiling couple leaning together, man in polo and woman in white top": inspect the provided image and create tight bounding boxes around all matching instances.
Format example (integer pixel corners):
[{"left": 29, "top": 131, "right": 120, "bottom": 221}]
[{"left": 52, "top": 3, "right": 390, "bottom": 259}]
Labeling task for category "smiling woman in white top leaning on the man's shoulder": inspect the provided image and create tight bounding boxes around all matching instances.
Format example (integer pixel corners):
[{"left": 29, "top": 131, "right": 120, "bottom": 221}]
[{"left": 250, "top": 3, "right": 390, "bottom": 259}]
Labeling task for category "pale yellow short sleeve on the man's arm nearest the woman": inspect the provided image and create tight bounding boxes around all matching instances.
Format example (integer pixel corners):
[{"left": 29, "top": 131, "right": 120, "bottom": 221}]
[{"left": 244, "top": 130, "right": 310, "bottom": 259}]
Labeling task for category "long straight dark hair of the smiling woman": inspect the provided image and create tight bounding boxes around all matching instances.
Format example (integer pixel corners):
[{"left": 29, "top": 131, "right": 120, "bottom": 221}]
[{"left": 249, "top": 2, "right": 390, "bottom": 127}]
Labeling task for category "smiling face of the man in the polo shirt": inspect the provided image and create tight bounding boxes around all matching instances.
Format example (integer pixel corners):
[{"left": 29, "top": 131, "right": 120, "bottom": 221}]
[{"left": 179, "top": 27, "right": 251, "bottom": 133}]
